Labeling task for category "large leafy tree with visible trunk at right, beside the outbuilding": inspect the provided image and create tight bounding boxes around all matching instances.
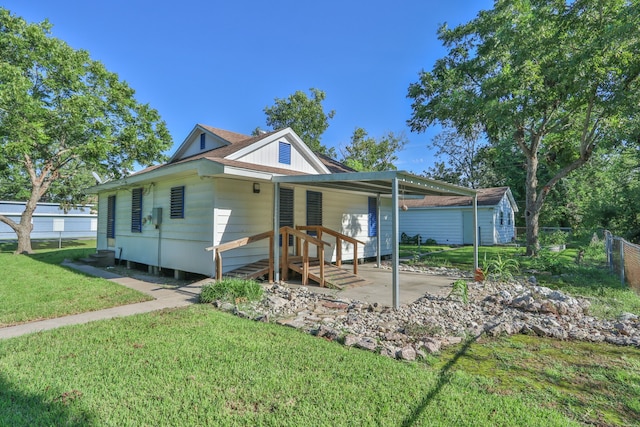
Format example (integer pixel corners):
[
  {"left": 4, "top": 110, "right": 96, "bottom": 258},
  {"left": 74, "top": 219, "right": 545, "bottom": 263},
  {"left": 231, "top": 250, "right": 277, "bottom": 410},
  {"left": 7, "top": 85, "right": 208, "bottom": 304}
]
[{"left": 409, "top": 0, "right": 640, "bottom": 254}]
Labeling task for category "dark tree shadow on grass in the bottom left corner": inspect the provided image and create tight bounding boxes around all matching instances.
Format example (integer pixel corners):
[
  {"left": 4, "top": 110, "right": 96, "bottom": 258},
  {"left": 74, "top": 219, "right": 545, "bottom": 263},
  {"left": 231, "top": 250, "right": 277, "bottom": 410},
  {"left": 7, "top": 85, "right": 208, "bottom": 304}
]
[{"left": 0, "top": 374, "right": 95, "bottom": 427}]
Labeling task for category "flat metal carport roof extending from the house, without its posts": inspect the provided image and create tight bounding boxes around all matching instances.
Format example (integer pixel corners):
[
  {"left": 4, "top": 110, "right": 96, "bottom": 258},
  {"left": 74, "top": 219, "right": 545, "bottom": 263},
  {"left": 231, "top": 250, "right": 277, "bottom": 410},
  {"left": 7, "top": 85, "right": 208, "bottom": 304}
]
[{"left": 272, "top": 171, "right": 476, "bottom": 196}]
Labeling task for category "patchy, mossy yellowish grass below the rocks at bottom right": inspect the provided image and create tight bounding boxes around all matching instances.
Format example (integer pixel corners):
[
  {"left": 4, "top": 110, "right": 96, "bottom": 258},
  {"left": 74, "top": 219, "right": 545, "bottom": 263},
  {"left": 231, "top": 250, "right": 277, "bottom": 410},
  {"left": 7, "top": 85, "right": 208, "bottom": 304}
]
[{"left": 434, "top": 335, "right": 640, "bottom": 426}]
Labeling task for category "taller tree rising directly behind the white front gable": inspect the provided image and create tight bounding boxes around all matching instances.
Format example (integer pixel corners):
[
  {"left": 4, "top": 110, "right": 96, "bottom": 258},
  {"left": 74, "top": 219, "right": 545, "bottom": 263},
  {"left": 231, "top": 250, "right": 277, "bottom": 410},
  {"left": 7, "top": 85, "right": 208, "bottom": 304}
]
[{"left": 264, "top": 88, "right": 336, "bottom": 156}]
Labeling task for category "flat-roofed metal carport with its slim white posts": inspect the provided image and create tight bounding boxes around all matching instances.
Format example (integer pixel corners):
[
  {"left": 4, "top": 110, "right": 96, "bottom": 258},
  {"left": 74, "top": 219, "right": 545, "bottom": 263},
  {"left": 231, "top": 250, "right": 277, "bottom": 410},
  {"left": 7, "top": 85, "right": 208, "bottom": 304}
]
[{"left": 272, "top": 171, "right": 478, "bottom": 309}]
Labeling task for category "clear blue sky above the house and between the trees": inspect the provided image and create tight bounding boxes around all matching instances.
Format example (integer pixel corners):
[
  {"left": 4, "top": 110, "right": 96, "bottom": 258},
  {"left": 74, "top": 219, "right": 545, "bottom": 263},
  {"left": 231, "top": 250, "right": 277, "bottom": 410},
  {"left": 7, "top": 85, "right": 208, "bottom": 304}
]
[{"left": 2, "top": 0, "right": 493, "bottom": 173}]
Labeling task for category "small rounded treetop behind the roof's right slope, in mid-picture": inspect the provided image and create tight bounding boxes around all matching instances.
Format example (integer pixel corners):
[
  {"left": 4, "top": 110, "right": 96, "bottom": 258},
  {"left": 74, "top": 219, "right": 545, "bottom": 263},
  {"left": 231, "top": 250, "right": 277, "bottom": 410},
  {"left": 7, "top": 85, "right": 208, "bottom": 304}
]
[{"left": 340, "top": 128, "right": 407, "bottom": 171}]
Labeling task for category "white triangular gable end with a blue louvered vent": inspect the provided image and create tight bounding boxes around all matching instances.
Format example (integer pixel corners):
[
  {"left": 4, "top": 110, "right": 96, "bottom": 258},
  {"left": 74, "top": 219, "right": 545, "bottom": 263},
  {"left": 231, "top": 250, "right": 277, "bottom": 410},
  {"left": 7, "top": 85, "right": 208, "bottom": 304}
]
[{"left": 227, "top": 128, "right": 329, "bottom": 174}]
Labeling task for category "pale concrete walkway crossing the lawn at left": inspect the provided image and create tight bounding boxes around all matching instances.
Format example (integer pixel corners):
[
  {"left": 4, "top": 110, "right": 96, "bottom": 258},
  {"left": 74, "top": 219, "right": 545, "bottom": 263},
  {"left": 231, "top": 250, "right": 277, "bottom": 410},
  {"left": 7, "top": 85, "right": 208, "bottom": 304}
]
[{"left": 0, "top": 263, "right": 206, "bottom": 339}]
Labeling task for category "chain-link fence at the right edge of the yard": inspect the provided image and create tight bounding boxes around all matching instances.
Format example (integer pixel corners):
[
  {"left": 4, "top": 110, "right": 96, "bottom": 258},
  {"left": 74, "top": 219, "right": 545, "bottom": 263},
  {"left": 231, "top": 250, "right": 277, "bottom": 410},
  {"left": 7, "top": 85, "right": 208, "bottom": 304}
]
[{"left": 604, "top": 230, "right": 640, "bottom": 293}]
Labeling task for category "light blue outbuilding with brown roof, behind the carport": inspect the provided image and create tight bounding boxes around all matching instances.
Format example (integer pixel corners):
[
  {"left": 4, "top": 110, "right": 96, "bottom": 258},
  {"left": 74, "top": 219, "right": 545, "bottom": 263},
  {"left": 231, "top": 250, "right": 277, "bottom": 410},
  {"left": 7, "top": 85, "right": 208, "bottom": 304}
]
[{"left": 400, "top": 187, "right": 518, "bottom": 246}]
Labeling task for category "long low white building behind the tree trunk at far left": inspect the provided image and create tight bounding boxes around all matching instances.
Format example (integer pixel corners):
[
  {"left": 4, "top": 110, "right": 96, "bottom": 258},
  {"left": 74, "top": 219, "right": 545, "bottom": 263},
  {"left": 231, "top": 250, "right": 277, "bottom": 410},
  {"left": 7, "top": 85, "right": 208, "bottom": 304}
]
[{"left": 0, "top": 201, "right": 98, "bottom": 240}]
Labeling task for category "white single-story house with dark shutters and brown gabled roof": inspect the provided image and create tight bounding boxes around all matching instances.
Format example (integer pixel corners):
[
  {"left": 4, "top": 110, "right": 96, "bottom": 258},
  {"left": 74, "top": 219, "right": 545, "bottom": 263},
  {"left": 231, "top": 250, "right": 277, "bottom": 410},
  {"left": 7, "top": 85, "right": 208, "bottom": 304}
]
[{"left": 89, "top": 124, "right": 475, "bottom": 308}]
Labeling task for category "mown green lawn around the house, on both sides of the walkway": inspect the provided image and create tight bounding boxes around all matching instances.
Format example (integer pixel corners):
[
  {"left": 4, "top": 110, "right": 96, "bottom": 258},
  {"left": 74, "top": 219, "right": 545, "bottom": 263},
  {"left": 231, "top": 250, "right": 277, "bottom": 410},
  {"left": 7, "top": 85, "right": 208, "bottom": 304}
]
[{"left": 0, "top": 239, "right": 640, "bottom": 426}]
